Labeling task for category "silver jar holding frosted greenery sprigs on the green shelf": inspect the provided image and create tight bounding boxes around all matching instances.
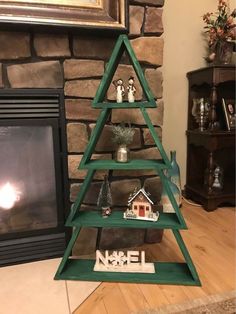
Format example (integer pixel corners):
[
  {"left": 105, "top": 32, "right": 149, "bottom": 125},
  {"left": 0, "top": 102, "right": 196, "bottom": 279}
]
[{"left": 112, "top": 123, "right": 135, "bottom": 162}]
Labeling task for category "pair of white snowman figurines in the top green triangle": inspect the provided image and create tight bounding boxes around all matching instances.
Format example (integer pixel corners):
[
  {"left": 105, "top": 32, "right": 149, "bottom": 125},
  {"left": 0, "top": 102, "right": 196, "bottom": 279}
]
[{"left": 113, "top": 76, "right": 136, "bottom": 103}]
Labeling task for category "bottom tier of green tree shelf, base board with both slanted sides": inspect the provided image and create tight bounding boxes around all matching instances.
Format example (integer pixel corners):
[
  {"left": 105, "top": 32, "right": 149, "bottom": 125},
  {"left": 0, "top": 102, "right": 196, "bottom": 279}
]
[{"left": 54, "top": 228, "right": 201, "bottom": 286}]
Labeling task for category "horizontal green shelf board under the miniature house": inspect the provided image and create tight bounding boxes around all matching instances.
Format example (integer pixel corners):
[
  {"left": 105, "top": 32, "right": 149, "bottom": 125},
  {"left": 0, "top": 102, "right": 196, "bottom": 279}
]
[{"left": 67, "top": 210, "right": 186, "bottom": 229}]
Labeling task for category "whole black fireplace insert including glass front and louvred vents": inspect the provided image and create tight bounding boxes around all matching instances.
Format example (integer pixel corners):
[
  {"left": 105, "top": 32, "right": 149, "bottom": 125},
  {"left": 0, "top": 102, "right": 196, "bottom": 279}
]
[{"left": 0, "top": 89, "right": 69, "bottom": 266}]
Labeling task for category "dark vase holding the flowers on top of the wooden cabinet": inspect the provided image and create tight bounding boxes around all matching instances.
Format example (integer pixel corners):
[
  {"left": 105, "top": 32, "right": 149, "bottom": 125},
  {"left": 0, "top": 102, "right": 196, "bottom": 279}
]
[{"left": 214, "top": 40, "right": 234, "bottom": 64}]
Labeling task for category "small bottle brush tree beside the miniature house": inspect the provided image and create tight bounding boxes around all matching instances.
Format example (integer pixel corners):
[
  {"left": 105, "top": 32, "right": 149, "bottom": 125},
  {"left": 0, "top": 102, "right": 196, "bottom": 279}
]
[{"left": 97, "top": 175, "right": 112, "bottom": 218}]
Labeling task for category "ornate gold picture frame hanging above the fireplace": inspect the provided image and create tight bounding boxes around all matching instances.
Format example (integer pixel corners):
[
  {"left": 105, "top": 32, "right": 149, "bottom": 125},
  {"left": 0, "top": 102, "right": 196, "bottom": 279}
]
[{"left": 0, "top": 0, "right": 128, "bottom": 32}]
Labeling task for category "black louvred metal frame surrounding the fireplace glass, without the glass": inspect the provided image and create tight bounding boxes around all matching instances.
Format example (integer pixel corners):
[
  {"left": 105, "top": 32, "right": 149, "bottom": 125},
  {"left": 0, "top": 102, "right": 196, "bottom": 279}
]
[{"left": 0, "top": 89, "right": 70, "bottom": 266}]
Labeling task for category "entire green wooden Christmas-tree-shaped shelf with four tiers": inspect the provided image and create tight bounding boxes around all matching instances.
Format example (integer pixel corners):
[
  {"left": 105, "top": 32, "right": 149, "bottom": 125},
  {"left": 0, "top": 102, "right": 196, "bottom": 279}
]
[{"left": 55, "top": 35, "right": 201, "bottom": 286}]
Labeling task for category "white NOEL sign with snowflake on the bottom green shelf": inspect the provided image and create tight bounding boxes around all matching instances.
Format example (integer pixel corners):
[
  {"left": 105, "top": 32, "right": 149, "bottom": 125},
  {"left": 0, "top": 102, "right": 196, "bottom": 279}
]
[{"left": 93, "top": 250, "right": 155, "bottom": 274}]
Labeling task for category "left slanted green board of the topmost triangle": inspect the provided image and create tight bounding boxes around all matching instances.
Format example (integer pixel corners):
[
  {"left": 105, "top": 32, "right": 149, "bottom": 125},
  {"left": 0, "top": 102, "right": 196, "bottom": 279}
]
[{"left": 92, "top": 36, "right": 125, "bottom": 108}]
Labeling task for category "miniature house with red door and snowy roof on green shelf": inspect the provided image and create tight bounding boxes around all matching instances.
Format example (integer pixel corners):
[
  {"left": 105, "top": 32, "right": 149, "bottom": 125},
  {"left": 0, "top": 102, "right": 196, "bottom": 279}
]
[{"left": 124, "top": 188, "right": 159, "bottom": 221}]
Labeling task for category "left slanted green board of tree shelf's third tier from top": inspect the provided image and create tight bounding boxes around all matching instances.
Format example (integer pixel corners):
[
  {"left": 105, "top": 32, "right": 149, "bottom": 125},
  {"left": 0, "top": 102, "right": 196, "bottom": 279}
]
[{"left": 66, "top": 169, "right": 95, "bottom": 226}]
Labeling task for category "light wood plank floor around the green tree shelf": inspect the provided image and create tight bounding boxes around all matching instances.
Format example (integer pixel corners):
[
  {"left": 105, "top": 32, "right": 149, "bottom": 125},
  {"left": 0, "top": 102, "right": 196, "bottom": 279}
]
[{"left": 74, "top": 203, "right": 236, "bottom": 314}]
